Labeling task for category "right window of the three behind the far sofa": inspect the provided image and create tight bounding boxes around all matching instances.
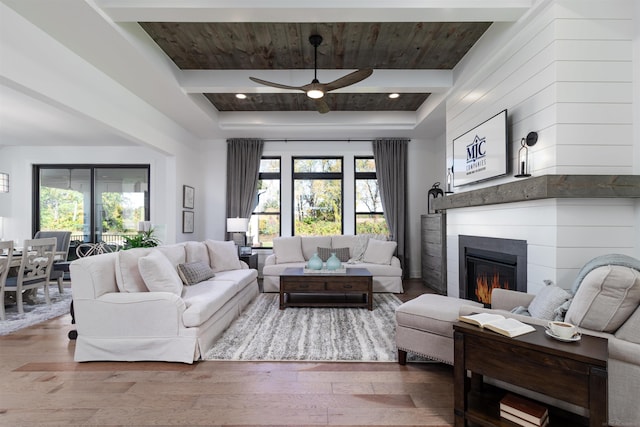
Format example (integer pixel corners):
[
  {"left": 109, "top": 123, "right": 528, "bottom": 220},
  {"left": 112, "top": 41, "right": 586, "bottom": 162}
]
[{"left": 354, "top": 157, "right": 389, "bottom": 234}]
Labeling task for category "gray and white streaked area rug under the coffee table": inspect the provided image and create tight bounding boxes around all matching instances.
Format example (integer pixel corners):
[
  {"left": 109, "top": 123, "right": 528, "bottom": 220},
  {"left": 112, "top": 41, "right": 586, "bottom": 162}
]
[{"left": 204, "top": 293, "right": 401, "bottom": 362}]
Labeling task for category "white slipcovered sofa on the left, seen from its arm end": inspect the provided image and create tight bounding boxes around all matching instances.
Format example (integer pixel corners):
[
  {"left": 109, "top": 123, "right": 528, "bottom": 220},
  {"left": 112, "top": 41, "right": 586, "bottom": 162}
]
[{"left": 70, "top": 240, "right": 259, "bottom": 363}]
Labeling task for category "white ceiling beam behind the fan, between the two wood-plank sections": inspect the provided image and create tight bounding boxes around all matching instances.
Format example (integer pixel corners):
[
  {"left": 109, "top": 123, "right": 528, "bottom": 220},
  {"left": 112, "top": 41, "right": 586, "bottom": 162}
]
[{"left": 178, "top": 70, "right": 453, "bottom": 93}]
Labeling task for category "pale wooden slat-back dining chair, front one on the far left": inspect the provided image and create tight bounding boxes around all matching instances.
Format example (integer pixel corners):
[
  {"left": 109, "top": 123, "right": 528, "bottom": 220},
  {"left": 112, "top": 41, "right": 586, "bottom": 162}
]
[{"left": 2, "top": 237, "right": 56, "bottom": 318}]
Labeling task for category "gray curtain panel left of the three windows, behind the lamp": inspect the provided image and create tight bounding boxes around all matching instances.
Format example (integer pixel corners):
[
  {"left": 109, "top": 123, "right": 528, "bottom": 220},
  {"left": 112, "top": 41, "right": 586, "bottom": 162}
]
[{"left": 227, "top": 138, "right": 264, "bottom": 222}]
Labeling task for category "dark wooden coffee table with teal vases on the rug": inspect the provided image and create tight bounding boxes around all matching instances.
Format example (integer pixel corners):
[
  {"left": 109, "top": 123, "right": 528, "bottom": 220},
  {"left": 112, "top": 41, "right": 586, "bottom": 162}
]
[{"left": 280, "top": 267, "right": 373, "bottom": 310}]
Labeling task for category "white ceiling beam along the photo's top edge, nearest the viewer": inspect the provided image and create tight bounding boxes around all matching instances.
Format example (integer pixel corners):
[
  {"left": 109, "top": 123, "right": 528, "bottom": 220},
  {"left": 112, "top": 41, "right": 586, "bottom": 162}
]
[{"left": 96, "top": 0, "right": 534, "bottom": 22}]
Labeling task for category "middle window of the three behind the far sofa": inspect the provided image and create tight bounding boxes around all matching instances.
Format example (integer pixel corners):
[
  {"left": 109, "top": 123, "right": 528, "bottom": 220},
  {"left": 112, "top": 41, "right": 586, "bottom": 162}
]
[{"left": 292, "top": 157, "right": 343, "bottom": 236}]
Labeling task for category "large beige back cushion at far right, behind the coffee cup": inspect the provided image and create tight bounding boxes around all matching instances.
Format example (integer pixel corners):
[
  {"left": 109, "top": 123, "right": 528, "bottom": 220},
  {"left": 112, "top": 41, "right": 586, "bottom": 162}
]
[{"left": 565, "top": 265, "right": 640, "bottom": 332}]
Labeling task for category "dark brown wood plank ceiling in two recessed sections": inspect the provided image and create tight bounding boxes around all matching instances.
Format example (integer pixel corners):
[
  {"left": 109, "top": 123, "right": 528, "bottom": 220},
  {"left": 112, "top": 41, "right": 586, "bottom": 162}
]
[{"left": 139, "top": 22, "right": 491, "bottom": 111}]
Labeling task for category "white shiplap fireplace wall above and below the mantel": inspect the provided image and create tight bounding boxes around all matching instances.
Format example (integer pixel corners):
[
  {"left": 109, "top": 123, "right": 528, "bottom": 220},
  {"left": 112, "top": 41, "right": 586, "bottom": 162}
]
[{"left": 447, "top": 0, "right": 640, "bottom": 296}]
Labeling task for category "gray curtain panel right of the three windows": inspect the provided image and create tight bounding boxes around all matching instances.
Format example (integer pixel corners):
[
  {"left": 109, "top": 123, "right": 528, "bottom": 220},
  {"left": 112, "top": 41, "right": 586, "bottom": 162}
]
[{"left": 373, "top": 138, "right": 409, "bottom": 277}]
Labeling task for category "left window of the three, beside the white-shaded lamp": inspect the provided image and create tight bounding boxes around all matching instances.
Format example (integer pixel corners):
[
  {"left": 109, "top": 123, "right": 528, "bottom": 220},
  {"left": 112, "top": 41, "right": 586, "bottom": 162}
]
[{"left": 247, "top": 157, "right": 280, "bottom": 248}]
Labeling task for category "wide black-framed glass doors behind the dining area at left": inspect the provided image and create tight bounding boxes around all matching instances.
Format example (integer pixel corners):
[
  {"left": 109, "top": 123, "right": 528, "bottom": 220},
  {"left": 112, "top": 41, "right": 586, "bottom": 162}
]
[{"left": 33, "top": 165, "right": 149, "bottom": 249}]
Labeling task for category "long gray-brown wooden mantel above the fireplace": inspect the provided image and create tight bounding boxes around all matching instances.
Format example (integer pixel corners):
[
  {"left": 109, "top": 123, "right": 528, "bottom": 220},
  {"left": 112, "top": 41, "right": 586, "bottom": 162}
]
[{"left": 432, "top": 175, "right": 640, "bottom": 210}]
